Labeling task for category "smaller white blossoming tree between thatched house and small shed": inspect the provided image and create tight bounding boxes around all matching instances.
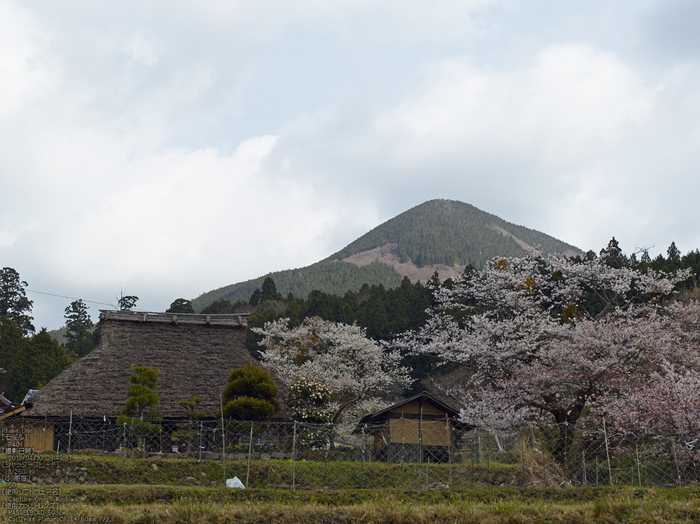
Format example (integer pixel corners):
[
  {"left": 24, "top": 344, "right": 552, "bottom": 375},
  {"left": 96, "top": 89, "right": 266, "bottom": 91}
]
[{"left": 253, "top": 317, "right": 412, "bottom": 422}]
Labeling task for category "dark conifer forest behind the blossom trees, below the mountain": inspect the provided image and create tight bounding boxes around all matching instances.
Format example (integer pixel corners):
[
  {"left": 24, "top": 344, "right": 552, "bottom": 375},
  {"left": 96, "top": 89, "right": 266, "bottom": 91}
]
[{"left": 196, "top": 238, "right": 700, "bottom": 394}]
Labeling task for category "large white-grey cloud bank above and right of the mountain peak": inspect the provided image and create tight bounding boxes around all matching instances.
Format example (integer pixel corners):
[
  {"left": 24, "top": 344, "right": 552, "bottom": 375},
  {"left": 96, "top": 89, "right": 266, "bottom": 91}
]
[{"left": 262, "top": 36, "right": 700, "bottom": 256}]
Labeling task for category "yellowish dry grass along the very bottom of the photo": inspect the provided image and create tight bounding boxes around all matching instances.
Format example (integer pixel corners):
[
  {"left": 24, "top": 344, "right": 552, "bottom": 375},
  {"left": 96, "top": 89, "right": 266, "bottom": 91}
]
[{"left": 6, "top": 489, "right": 700, "bottom": 524}]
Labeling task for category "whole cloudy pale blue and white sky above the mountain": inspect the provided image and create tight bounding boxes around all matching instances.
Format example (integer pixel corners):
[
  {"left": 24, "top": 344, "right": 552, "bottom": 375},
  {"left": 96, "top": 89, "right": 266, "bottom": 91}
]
[{"left": 0, "top": 0, "right": 700, "bottom": 329}]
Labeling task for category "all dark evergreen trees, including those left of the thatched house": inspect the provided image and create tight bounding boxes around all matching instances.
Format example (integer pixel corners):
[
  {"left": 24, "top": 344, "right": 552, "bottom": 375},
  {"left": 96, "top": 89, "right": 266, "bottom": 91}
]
[{"left": 0, "top": 238, "right": 700, "bottom": 405}]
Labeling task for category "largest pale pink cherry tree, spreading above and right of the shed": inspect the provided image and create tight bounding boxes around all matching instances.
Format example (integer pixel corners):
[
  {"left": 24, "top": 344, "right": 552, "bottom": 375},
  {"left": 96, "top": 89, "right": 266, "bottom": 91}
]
[{"left": 394, "top": 253, "right": 689, "bottom": 460}]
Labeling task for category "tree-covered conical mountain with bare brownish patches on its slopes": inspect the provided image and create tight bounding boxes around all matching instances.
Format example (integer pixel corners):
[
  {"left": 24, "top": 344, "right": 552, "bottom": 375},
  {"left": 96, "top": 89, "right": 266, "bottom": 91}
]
[{"left": 193, "top": 200, "right": 582, "bottom": 311}]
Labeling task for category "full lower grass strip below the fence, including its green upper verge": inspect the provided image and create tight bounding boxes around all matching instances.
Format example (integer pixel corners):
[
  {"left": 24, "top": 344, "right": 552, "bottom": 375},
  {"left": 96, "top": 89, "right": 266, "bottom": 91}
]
[{"left": 0, "top": 485, "right": 700, "bottom": 524}]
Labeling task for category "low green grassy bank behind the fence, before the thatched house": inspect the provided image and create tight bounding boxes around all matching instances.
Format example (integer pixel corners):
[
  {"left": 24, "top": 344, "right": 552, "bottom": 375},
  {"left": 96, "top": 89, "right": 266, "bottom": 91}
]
[{"left": 0, "top": 454, "right": 518, "bottom": 489}]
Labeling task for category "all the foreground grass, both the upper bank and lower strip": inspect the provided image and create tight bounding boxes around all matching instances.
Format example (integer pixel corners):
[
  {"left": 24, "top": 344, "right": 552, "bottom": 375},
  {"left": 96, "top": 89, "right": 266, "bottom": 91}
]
[{"left": 0, "top": 454, "right": 700, "bottom": 524}]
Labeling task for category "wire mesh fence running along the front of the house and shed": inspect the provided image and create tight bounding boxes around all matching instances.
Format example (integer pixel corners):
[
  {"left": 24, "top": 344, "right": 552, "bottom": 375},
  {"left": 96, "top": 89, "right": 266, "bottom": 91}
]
[{"left": 0, "top": 418, "right": 700, "bottom": 489}]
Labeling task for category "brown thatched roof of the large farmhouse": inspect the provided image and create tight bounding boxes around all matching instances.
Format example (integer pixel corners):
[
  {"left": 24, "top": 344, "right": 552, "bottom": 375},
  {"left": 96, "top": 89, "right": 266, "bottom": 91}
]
[{"left": 21, "top": 311, "right": 253, "bottom": 418}]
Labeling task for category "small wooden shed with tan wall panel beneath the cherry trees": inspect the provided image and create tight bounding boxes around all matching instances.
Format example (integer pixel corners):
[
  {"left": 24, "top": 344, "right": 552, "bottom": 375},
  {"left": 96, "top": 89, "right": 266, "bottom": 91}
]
[{"left": 354, "top": 392, "right": 459, "bottom": 462}]
